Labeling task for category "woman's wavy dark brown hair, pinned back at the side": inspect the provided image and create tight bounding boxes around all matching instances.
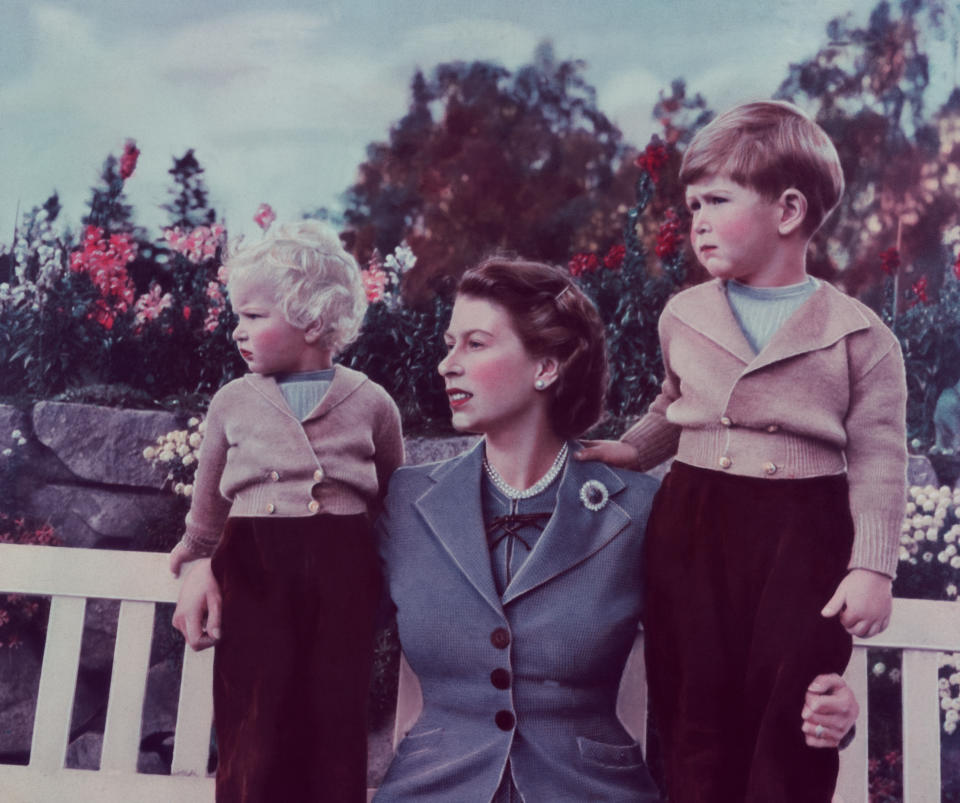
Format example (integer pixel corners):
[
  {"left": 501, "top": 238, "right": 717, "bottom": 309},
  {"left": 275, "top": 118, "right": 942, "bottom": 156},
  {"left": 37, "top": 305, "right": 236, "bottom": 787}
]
[{"left": 457, "top": 256, "right": 608, "bottom": 438}]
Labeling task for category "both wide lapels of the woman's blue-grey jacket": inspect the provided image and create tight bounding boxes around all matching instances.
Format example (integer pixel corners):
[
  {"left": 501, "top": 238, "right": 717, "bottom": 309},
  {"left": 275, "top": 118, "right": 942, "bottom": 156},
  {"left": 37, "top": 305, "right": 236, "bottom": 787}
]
[{"left": 415, "top": 441, "right": 631, "bottom": 612}]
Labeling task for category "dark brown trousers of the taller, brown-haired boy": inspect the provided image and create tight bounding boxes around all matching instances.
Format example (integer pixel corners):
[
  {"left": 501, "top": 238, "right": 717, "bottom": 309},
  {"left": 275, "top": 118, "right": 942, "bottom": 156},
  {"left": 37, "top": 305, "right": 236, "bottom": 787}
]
[{"left": 644, "top": 462, "right": 852, "bottom": 803}]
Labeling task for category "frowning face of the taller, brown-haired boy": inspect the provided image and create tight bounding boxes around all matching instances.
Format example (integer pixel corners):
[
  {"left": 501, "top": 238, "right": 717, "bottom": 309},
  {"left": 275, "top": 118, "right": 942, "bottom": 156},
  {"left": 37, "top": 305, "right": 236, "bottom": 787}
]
[{"left": 686, "top": 174, "right": 782, "bottom": 287}]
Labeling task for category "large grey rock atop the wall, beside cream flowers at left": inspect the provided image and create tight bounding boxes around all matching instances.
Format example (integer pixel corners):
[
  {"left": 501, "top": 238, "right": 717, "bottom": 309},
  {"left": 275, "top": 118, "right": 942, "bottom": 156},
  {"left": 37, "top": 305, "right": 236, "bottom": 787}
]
[{"left": 33, "top": 402, "right": 178, "bottom": 488}]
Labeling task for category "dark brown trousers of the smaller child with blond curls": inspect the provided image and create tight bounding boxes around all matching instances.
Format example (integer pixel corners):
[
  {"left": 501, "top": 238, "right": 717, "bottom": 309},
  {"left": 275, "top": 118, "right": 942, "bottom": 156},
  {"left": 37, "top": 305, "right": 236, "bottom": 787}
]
[{"left": 212, "top": 516, "right": 380, "bottom": 803}]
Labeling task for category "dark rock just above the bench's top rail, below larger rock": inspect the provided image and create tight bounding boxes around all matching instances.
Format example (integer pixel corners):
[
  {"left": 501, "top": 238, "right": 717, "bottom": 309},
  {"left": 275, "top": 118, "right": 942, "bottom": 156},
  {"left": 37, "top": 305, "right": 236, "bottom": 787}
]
[{"left": 25, "top": 485, "right": 179, "bottom": 547}]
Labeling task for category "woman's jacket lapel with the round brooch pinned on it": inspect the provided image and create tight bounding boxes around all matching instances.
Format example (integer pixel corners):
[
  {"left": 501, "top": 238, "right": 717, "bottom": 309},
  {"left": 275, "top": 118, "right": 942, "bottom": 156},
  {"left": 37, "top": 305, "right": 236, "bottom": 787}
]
[{"left": 498, "top": 444, "right": 632, "bottom": 605}]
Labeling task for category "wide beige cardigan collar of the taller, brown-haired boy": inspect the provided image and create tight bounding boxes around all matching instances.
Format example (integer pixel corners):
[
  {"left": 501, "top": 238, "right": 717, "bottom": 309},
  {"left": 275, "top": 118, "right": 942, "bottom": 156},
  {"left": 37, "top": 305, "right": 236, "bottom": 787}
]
[{"left": 670, "top": 279, "right": 870, "bottom": 373}]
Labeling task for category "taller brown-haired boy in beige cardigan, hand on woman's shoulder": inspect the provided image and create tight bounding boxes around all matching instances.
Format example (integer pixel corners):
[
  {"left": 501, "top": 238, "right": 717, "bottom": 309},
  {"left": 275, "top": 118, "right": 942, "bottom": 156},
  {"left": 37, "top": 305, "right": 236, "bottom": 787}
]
[{"left": 579, "top": 101, "right": 906, "bottom": 803}]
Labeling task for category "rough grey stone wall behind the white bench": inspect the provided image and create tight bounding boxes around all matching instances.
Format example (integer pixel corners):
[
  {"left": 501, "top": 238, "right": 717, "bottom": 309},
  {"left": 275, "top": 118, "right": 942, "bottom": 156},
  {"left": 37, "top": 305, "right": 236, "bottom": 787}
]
[{"left": 0, "top": 402, "right": 476, "bottom": 772}]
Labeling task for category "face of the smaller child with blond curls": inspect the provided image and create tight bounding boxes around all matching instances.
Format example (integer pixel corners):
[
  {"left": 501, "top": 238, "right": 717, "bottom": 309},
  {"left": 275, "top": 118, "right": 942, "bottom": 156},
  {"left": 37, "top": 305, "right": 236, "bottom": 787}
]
[{"left": 230, "top": 277, "right": 329, "bottom": 374}]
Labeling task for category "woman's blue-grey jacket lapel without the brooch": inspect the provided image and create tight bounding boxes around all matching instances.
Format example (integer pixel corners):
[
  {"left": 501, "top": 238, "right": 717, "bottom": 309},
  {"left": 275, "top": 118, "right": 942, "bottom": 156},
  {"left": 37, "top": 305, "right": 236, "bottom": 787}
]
[{"left": 414, "top": 441, "right": 503, "bottom": 615}]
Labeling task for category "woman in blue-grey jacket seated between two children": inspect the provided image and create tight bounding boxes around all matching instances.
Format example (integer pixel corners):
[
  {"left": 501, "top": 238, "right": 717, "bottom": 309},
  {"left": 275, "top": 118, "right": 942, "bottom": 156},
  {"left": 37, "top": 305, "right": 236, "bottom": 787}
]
[{"left": 175, "top": 259, "right": 855, "bottom": 803}]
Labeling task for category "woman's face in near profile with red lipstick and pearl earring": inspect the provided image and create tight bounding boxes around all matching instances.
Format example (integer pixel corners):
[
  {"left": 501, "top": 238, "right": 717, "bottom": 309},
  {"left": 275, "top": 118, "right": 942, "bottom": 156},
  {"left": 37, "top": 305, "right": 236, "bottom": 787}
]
[{"left": 438, "top": 296, "right": 554, "bottom": 434}]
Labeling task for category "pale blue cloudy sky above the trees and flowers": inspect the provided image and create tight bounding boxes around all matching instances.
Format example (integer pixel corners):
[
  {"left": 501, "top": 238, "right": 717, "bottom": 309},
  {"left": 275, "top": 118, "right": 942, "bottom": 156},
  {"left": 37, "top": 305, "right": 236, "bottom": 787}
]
[{"left": 0, "top": 0, "right": 953, "bottom": 243}]
